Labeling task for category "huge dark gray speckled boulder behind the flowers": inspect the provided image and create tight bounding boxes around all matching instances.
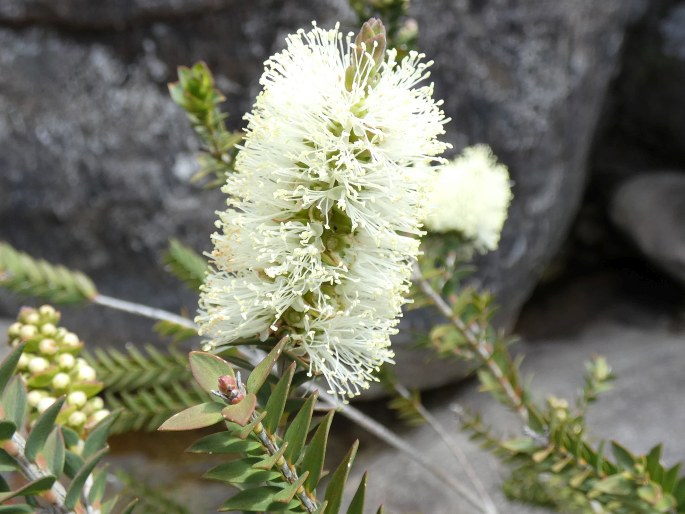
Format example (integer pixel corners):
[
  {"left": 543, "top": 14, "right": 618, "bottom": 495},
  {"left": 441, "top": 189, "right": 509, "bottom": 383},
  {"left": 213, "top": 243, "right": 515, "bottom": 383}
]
[{"left": 0, "top": 0, "right": 644, "bottom": 387}]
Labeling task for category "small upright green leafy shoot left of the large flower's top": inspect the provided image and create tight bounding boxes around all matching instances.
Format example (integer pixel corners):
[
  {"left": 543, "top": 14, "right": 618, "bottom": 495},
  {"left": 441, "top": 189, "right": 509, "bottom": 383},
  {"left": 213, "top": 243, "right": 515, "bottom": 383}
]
[{"left": 169, "top": 62, "right": 243, "bottom": 187}]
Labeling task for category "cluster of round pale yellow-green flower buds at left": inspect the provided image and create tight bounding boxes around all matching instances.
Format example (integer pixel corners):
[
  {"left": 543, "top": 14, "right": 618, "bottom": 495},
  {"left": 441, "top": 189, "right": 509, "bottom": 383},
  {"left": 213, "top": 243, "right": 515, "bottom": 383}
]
[{"left": 8, "top": 305, "right": 109, "bottom": 435}]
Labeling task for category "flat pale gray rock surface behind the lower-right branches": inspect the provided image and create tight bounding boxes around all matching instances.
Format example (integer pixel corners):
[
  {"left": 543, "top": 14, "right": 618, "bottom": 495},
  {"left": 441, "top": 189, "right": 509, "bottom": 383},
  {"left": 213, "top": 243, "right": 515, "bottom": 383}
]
[{"left": 348, "top": 321, "right": 685, "bottom": 514}]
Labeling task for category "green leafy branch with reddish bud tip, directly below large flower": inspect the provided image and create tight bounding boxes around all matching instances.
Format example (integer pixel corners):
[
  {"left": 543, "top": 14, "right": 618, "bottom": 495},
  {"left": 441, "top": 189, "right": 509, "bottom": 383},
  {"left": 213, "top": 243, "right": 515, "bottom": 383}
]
[{"left": 160, "top": 338, "right": 380, "bottom": 514}]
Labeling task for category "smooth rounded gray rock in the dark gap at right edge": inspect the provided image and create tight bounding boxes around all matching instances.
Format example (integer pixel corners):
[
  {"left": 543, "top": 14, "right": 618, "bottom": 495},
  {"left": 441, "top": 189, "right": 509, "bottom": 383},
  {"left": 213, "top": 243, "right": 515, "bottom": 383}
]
[{"left": 611, "top": 171, "right": 685, "bottom": 284}]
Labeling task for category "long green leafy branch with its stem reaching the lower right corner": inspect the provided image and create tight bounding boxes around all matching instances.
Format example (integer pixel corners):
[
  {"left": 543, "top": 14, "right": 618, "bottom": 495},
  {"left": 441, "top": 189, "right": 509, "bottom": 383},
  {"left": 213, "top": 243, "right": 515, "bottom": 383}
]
[{"left": 414, "top": 264, "right": 685, "bottom": 514}]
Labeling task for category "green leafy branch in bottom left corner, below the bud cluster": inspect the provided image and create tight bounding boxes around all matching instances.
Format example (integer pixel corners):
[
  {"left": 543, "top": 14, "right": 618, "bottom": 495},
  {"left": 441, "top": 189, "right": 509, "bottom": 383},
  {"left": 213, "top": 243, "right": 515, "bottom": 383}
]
[{"left": 0, "top": 345, "right": 133, "bottom": 514}]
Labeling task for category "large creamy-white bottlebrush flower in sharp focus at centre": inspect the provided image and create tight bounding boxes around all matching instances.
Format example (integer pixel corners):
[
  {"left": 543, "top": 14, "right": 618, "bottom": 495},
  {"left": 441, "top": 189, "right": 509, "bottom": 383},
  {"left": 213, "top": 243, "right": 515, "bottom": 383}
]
[{"left": 196, "top": 22, "right": 448, "bottom": 396}]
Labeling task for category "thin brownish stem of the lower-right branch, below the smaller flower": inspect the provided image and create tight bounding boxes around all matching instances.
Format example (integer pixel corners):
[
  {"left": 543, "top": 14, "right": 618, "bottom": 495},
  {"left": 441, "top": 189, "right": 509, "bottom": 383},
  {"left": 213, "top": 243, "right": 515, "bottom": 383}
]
[{"left": 413, "top": 266, "right": 529, "bottom": 426}]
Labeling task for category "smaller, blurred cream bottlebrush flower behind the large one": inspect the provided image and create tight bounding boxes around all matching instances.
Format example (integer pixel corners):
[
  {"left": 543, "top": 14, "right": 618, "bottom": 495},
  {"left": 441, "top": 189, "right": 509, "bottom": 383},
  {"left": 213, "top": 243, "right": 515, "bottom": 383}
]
[{"left": 426, "top": 145, "right": 512, "bottom": 252}]
